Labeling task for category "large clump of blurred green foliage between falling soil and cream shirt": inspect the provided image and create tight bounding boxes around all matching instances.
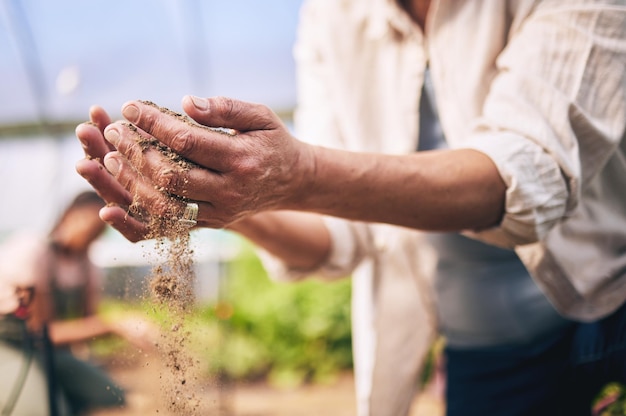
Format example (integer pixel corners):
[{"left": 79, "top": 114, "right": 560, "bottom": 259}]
[{"left": 205, "top": 247, "right": 352, "bottom": 385}]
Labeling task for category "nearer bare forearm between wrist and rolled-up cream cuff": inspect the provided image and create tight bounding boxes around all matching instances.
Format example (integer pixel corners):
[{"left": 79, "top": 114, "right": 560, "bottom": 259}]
[{"left": 291, "top": 147, "right": 506, "bottom": 231}]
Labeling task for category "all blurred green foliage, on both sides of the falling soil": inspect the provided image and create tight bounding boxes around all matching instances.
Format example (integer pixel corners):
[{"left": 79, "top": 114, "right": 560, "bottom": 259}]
[{"left": 97, "top": 245, "right": 352, "bottom": 386}]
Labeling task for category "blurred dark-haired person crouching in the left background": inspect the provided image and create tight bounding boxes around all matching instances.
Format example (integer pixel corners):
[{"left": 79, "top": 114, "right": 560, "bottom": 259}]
[{"left": 0, "top": 191, "right": 154, "bottom": 415}]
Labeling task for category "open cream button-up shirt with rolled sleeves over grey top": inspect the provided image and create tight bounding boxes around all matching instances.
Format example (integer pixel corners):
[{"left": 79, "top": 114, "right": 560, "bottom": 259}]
[{"left": 258, "top": 0, "right": 626, "bottom": 415}]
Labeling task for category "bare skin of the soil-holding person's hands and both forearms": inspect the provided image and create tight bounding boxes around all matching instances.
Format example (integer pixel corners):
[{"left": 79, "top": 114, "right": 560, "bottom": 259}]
[{"left": 77, "top": 96, "right": 505, "bottom": 268}]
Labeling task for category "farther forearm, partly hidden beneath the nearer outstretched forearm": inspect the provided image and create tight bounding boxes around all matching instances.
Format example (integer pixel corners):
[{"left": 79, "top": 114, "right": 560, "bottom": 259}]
[{"left": 229, "top": 211, "right": 330, "bottom": 270}]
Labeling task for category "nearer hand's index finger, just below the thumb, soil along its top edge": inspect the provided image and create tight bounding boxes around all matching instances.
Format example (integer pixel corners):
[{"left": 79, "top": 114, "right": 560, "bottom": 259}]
[{"left": 122, "top": 101, "right": 243, "bottom": 172}]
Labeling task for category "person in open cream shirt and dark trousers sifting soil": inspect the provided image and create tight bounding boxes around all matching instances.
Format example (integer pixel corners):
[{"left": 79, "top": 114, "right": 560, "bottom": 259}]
[{"left": 77, "top": 0, "right": 626, "bottom": 416}]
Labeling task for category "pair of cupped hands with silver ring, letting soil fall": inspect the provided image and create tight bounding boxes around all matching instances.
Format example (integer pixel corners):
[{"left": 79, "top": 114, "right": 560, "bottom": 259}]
[{"left": 76, "top": 96, "right": 314, "bottom": 241}]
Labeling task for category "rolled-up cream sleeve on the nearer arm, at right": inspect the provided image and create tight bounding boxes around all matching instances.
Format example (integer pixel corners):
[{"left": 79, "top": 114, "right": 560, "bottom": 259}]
[{"left": 464, "top": 2, "right": 626, "bottom": 247}]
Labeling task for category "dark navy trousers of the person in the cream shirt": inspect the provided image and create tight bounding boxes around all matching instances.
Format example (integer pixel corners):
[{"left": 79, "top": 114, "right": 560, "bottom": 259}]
[{"left": 445, "top": 305, "right": 626, "bottom": 416}]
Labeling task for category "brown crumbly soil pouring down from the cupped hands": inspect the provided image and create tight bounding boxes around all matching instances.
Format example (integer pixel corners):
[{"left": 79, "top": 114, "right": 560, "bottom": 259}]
[{"left": 122, "top": 102, "right": 212, "bottom": 415}]
